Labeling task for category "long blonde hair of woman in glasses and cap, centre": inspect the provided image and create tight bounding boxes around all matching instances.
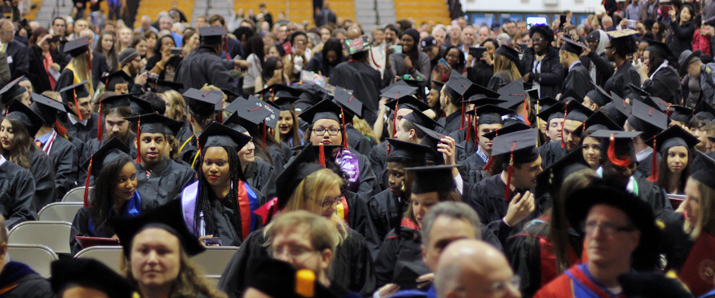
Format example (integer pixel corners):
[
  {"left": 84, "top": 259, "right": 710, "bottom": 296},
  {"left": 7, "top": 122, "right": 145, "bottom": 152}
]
[{"left": 283, "top": 169, "right": 347, "bottom": 239}]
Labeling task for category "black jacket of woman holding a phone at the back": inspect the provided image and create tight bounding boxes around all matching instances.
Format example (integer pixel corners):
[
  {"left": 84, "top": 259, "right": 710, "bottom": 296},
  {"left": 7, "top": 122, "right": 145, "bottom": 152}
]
[{"left": 521, "top": 47, "right": 564, "bottom": 98}]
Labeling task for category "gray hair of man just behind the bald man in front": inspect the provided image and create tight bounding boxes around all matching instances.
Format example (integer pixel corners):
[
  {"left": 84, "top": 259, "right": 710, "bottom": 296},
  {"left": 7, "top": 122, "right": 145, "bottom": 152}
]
[{"left": 420, "top": 202, "right": 482, "bottom": 245}]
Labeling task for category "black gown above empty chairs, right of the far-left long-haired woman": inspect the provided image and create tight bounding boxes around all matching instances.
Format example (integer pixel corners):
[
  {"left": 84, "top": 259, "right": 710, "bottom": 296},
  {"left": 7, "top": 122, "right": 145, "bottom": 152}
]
[{"left": 50, "top": 135, "right": 79, "bottom": 200}]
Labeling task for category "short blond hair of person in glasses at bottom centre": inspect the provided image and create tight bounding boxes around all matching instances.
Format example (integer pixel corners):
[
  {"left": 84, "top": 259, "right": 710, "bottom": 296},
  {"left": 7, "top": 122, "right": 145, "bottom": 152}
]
[{"left": 263, "top": 210, "right": 342, "bottom": 252}]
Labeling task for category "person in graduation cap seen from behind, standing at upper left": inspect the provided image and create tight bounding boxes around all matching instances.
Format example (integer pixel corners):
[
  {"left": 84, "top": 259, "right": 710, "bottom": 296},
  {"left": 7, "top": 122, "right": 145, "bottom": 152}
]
[{"left": 174, "top": 27, "right": 239, "bottom": 93}]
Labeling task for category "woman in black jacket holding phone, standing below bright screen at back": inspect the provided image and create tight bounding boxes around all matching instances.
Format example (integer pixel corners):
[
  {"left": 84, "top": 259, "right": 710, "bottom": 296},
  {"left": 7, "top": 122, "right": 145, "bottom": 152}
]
[{"left": 521, "top": 25, "right": 564, "bottom": 98}]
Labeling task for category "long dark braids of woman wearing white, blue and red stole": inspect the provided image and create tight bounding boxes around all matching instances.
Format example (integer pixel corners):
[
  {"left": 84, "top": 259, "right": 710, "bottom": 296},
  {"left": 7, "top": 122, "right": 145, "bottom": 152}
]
[{"left": 193, "top": 146, "right": 248, "bottom": 237}]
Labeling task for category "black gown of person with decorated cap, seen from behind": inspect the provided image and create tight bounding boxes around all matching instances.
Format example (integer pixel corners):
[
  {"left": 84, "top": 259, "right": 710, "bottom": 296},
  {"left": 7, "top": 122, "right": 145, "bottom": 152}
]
[{"left": 330, "top": 61, "right": 383, "bottom": 125}]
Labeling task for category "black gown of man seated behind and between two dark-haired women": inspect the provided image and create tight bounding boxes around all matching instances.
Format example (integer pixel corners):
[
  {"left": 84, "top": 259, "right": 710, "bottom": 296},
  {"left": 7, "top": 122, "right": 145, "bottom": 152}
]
[{"left": 135, "top": 158, "right": 196, "bottom": 210}]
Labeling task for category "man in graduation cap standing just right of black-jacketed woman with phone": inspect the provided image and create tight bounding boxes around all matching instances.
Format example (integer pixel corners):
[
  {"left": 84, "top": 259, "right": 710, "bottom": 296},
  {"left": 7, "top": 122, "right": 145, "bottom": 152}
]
[{"left": 559, "top": 37, "right": 594, "bottom": 98}]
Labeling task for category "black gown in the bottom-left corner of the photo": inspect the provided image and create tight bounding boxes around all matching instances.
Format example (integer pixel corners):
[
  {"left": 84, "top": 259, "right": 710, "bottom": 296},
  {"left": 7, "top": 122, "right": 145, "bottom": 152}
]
[{"left": 0, "top": 261, "right": 55, "bottom": 298}]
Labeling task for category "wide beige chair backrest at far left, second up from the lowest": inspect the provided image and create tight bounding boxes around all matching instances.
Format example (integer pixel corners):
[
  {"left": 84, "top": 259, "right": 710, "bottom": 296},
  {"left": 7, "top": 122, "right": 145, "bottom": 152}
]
[{"left": 7, "top": 221, "right": 72, "bottom": 254}]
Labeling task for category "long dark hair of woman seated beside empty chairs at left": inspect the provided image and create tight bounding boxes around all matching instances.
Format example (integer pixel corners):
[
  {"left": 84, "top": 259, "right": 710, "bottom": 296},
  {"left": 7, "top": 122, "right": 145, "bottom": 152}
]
[{"left": 87, "top": 154, "right": 132, "bottom": 237}]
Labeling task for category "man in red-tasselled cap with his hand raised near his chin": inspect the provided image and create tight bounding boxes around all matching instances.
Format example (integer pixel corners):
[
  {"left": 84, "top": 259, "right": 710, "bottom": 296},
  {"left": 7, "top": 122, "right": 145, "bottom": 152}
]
[{"left": 462, "top": 129, "right": 544, "bottom": 243}]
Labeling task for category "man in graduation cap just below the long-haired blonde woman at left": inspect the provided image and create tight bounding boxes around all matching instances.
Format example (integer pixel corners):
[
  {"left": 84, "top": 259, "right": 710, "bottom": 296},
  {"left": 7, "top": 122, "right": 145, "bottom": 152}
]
[{"left": 58, "top": 82, "right": 99, "bottom": 144}]
